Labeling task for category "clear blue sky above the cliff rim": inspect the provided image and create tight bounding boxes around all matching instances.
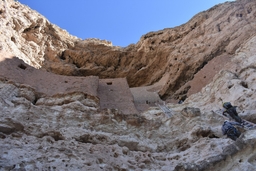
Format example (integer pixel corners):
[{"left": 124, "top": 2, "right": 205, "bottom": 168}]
[{"left": 19, "top": 0, "right": 234, "bottom": 47}]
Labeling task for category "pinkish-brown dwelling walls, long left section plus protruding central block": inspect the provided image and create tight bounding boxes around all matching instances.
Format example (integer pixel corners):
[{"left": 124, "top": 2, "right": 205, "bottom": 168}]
[{"left": 0, "top": 57, "right": 138, "bottom": 114}]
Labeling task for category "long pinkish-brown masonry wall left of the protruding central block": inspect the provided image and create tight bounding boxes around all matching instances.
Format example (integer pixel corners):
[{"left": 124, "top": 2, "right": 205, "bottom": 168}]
[{"left": 0, "top": 57, "right": 98, "bottom": 98}]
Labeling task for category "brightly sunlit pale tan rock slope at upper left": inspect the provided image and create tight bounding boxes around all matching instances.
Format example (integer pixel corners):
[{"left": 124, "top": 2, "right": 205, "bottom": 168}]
[{"left": 0, "top": 0, "right": 79, "bottom": 70}]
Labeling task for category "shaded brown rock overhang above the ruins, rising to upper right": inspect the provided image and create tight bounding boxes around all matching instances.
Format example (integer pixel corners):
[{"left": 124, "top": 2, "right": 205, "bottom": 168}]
[{"left": 42, "top": 1, "right": 255, "bottom": 98}]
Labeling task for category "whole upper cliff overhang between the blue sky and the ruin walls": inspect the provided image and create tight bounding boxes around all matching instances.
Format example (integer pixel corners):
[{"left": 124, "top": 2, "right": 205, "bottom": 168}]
[{"left": 1, "top": 0, "right": 256, "bottom": 99}]
